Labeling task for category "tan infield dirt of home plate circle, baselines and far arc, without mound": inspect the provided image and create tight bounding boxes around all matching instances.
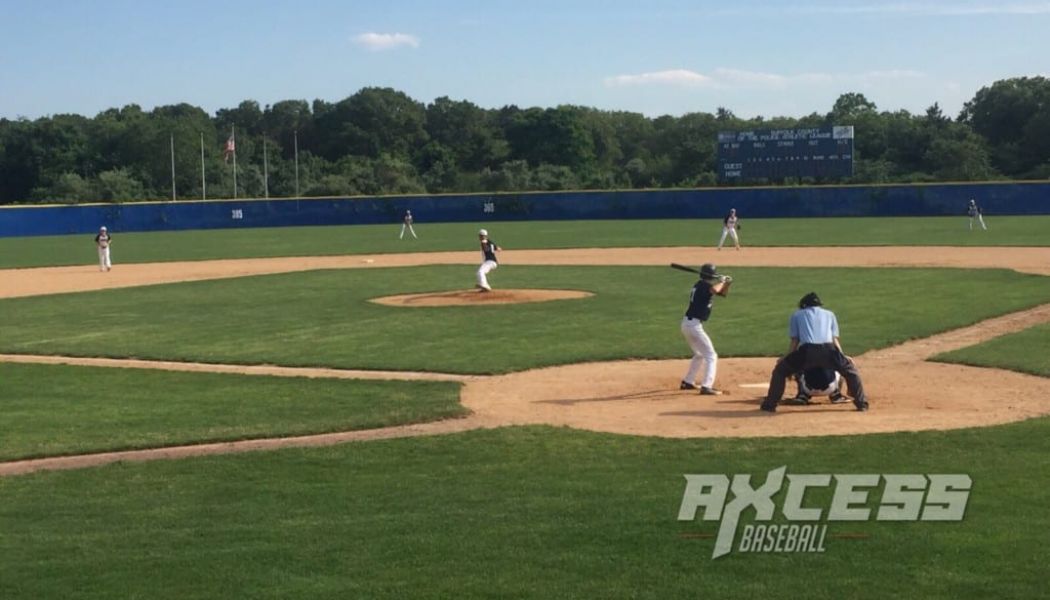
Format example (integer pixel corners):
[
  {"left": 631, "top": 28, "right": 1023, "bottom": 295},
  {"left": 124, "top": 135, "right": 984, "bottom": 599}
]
[{"left": 0, "top": 248, "right": 1050, "bottom": 475}]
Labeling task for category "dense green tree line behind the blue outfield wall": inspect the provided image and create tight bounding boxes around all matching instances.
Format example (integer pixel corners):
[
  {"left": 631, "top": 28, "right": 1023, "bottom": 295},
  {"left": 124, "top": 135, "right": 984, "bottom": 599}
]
[{"left": 0, "top": 77, "right": 1050, "bottom": 204}]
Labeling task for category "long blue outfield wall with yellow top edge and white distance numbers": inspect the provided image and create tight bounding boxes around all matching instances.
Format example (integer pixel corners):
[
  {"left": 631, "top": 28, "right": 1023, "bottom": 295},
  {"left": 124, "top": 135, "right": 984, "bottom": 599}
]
[{"left": 0, "top": 182, "right": 1050, "bottom": 237}]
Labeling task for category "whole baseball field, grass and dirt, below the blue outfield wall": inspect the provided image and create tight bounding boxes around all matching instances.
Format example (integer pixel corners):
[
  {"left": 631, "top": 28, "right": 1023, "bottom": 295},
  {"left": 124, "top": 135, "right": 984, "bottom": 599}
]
[{"left": 0, "top": 216, "right": 1050, "bottom": 599}]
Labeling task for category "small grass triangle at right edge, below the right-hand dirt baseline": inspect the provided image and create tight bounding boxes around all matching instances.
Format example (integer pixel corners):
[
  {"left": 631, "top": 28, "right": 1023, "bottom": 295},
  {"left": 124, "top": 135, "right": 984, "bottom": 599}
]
[{"left": 933, "top": 324, "right": 1050, "bottom": 377}]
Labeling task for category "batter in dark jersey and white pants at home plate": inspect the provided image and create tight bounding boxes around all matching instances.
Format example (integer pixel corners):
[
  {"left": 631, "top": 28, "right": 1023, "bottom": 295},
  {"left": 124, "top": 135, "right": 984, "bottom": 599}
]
[{"left": 678, "top": 263, "right": 733, "bottom": 396}]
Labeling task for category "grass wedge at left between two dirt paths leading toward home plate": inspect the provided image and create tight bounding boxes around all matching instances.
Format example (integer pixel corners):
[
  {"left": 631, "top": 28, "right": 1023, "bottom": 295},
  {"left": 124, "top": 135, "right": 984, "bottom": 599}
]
[{"left": 0, "top": 363, "right": 466, "bottom": 462}]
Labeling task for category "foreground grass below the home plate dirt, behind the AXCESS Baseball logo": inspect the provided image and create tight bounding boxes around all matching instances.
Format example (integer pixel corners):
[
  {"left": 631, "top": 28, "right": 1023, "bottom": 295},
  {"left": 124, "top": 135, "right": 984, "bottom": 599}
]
[{"left": 0, "top": 417, "right": 1050, "bottom": 600}]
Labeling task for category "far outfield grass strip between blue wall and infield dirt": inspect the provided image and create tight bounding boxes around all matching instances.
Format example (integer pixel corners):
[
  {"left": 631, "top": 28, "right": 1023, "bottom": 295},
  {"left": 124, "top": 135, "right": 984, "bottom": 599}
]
[{"left": 0, "top": 215, "right": 1050, "bottom": 268}]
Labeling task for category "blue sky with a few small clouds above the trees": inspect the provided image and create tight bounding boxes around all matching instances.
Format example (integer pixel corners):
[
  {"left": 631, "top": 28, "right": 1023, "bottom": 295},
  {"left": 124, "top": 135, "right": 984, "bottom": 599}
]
[{"left": 0, "top": 0, "right": 1050, "bottom": 119}]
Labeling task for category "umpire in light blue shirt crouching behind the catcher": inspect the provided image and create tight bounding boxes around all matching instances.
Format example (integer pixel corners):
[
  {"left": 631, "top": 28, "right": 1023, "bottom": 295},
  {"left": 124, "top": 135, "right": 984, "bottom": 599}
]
[{"left": 761, "top": 292, "right": 867, "bottom": 413}]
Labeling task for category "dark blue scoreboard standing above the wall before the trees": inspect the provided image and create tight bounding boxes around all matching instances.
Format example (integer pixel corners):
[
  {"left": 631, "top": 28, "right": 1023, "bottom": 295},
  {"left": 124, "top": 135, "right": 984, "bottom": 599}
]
[{"left": 718, "top": 125, "right": 854, "bottom": 183}]
